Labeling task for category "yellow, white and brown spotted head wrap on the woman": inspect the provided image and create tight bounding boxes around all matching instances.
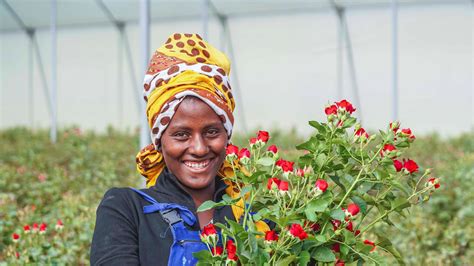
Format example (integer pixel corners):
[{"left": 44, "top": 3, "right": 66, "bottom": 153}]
[{"left": 136, "top": 33, "right": 235, "bottom": 187}]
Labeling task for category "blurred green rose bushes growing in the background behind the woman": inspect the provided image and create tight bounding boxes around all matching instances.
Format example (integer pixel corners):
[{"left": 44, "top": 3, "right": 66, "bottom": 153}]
[{"left": 0, "top": 124, "right": 474, "bottom": 265}]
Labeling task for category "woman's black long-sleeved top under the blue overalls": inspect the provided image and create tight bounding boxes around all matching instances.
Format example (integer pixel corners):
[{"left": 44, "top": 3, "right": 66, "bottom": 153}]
[{"left": 90, "top": 169, "right": 234, "bottom": 265}]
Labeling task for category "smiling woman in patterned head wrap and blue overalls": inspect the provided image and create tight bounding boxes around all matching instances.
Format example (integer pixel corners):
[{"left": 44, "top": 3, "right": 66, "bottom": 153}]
[{"left": 91, "top": 33, "right": 248, "bottom": 265}]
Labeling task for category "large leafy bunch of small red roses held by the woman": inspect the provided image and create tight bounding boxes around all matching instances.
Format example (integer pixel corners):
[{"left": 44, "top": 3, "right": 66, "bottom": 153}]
[{"left": 194, "top": 100, "right": 440, "bottom": 265}]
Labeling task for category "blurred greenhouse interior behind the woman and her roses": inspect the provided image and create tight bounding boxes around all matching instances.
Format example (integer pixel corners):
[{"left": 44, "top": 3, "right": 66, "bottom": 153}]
[{"left": 0, "top": 0, "right": 474, "bottom": 265}]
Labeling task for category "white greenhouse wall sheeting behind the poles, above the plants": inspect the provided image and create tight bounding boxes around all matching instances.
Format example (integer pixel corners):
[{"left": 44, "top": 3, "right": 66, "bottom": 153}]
[{"left": 0, "top": 5, "right": 474, "bottom": 135}]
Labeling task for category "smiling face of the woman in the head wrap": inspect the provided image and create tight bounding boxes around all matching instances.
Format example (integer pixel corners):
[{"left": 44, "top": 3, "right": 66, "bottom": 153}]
[{"left": 161, "top": 97, "right": 227, "bottom": 190}]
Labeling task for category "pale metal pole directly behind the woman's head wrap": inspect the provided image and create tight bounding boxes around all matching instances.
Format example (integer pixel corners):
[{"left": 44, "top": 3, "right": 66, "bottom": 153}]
[{"left": 139, "top": 0, "right": 150, "bottom": 148}]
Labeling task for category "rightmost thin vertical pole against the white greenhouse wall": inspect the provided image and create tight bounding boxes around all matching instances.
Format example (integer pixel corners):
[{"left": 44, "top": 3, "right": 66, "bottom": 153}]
[{"left": 392, "top": 0, "right": 398, "bottom": 121}]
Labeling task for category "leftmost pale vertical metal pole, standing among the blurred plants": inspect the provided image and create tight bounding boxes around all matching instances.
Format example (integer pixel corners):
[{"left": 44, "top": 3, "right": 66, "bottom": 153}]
[{"left": 50, "top": 0, "right": 58, "bottom": 143}]
